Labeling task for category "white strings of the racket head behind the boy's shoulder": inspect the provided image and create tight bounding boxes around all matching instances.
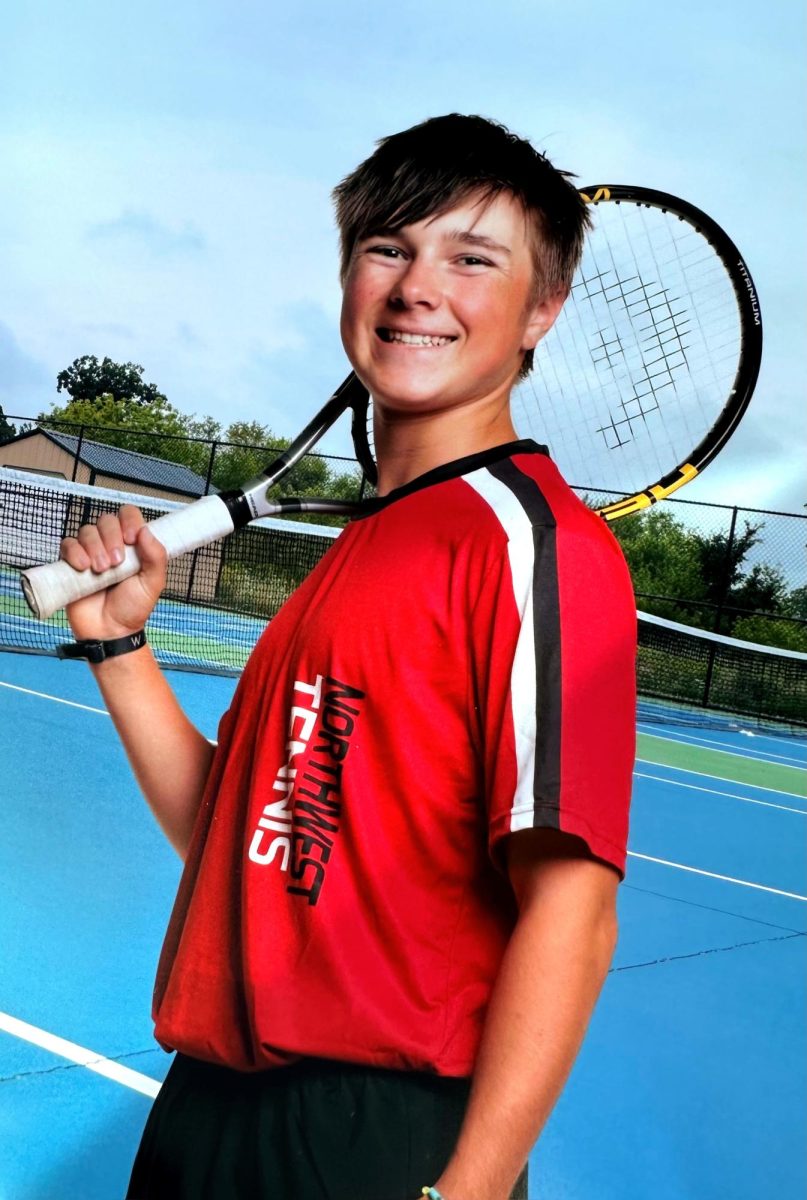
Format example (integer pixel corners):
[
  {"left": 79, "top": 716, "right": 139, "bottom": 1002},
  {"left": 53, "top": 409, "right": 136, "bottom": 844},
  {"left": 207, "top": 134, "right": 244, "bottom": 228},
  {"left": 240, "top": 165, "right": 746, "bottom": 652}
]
[{"left": 514, "top": 196, "right": 741, "bottom": 493}]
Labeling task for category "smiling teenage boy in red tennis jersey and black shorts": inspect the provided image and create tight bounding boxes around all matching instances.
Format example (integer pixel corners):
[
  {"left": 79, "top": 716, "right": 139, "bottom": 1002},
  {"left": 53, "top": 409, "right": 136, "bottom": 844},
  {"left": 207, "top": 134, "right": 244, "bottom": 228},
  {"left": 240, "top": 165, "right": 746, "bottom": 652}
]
[{"left": 64, "top": 115, "right": 634, "bottom": 1200}]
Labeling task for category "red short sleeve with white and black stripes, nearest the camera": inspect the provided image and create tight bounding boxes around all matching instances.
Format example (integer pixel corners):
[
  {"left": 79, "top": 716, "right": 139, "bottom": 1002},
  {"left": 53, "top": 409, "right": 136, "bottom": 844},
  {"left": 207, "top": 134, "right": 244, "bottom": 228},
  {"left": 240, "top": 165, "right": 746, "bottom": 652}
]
[{"left": 471, "top": 481, "right": 636, "bottom": 877}]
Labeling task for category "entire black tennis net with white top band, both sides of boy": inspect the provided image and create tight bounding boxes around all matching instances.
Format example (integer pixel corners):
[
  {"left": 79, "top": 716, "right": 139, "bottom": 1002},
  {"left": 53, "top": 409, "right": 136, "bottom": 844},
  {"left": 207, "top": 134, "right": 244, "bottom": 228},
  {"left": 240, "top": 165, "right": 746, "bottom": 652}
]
[{"left": 0, "top": 468, "right": 807, "bottom": 728}]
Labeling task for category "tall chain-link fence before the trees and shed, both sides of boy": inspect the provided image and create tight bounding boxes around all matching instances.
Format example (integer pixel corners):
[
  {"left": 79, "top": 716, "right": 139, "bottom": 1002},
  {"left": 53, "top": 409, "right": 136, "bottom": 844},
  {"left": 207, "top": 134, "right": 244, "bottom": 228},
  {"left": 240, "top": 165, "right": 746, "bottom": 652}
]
[{"left": 0, "top": 416, "right": 807, "bottom": 650}]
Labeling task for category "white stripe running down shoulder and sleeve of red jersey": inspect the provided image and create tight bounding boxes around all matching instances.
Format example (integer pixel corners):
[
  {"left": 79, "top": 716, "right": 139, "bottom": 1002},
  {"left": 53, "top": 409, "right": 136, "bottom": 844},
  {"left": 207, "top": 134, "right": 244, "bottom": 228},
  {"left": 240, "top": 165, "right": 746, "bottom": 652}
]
[{"left": 462, "top": 467, "right": 536, "bottom": 833}]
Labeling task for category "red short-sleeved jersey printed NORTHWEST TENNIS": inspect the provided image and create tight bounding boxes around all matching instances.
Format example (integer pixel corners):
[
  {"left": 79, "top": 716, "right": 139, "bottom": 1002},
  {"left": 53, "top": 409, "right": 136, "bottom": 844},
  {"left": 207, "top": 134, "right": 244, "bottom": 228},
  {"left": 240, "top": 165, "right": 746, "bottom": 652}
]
[{"left": 155, "top": 442, "right": 635, "bottom": 1075}]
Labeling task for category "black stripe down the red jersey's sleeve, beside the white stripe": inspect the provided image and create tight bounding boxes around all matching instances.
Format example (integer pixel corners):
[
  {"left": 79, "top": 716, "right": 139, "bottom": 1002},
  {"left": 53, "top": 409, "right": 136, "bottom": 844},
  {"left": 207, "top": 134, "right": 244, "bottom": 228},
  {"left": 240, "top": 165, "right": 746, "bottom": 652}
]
[{"left": 488, "top": 458, "right": 562, "bottom": 829}]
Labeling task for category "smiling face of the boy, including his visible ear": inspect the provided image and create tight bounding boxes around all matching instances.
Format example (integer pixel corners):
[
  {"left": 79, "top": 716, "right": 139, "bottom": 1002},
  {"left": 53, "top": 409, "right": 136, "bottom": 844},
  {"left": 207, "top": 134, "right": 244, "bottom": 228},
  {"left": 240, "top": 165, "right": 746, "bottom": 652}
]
[{"left": 341, "top": 194, "right": 563, "bottom": 414}]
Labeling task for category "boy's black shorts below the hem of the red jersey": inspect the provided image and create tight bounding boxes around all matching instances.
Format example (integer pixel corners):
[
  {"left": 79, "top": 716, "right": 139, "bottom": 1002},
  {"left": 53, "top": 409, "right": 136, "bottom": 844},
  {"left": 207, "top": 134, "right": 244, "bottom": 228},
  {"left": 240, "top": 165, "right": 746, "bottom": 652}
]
[{"left": 127, "top": 1055, "right": 527, "bottom": 1200}]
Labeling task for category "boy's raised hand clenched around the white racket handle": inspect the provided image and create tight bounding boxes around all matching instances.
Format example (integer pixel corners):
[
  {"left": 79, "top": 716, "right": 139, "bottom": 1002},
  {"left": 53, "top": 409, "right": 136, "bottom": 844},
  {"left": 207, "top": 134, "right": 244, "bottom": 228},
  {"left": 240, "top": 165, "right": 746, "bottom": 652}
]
[{"left": 61, "top": 504, "right": 168, "bottom": 641}]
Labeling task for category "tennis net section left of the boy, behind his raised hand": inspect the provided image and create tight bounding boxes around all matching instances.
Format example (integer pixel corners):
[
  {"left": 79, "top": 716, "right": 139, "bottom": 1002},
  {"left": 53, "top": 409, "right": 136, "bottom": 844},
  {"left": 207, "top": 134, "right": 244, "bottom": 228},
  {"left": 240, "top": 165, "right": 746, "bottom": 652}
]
[{"left": 0, "top": 468, "right": 339, "bottom": 674}]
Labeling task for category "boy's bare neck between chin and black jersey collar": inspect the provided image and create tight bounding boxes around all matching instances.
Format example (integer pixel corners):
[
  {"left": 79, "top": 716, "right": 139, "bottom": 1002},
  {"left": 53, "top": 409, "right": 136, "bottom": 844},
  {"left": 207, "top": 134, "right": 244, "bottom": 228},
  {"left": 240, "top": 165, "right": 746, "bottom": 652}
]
[{"left": 372, "top": 397, "right": 518, "bottom": 496}]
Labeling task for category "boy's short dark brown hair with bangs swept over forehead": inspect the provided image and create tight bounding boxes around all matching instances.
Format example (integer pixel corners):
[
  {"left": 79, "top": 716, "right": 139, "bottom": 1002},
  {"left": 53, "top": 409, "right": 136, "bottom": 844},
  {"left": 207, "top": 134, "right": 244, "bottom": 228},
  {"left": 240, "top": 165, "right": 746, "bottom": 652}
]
[{"left": 334, "top": 113, "right": 590, "bottom": 293}]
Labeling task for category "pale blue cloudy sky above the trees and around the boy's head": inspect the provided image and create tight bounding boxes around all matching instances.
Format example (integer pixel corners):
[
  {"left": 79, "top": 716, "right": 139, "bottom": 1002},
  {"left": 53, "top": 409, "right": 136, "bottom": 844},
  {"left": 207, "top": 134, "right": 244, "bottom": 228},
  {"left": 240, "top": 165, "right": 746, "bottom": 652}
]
[{"left": 0, "top": 0, "right": 807, "bottom": 511}]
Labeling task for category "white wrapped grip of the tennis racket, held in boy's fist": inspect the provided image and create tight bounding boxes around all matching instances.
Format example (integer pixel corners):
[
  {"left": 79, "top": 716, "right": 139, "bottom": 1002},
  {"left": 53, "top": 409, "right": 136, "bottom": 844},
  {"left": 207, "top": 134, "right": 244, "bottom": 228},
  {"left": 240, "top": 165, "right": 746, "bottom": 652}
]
[{"left": 20, "top": 496, "right": 234, "bottom": 620}]
